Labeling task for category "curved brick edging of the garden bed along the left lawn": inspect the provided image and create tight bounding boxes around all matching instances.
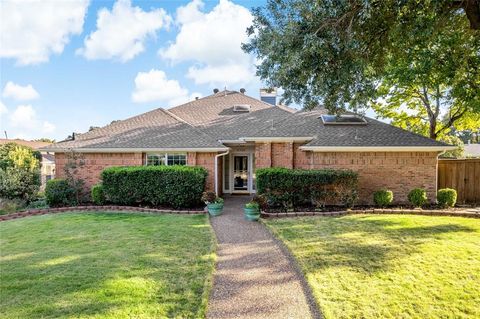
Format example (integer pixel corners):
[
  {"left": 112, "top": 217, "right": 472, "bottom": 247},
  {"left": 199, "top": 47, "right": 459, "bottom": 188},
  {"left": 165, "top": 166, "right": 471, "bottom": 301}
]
[{"left": 0, "top": 206, "right": 205, "bottom": 222}]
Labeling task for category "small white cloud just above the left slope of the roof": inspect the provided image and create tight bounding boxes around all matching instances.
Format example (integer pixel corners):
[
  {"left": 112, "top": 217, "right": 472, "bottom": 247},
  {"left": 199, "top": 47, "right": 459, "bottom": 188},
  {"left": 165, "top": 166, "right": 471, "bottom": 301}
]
[{"left": 132, "top": 69, "right": 201, "bottom": 106}]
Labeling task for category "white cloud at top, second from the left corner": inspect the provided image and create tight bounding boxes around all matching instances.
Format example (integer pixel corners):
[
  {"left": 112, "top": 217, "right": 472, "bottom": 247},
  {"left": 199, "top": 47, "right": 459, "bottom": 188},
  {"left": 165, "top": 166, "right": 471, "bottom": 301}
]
[{"left": 77, "top": 0, "right": 171, "bottom": 62}]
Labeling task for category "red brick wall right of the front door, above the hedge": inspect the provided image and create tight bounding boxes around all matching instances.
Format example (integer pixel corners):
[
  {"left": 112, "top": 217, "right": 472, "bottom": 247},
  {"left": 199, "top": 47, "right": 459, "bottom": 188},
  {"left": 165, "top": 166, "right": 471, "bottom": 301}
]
[{"left": 255, "top": 143, "right": 437, "bottom": 204}]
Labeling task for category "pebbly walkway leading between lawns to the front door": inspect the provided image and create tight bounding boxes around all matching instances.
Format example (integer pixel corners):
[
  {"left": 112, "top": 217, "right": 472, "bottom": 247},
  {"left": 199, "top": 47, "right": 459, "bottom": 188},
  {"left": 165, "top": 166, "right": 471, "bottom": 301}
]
[{"left": 207, "top": 196, "right": 320, "bottom": 319}]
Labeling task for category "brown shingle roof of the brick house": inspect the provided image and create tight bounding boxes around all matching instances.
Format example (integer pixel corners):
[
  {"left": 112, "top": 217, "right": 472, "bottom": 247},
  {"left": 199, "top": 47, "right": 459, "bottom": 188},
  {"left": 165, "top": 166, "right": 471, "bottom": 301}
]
[{"left": 41, "top": 91, "right": 446, "bottom": 151}]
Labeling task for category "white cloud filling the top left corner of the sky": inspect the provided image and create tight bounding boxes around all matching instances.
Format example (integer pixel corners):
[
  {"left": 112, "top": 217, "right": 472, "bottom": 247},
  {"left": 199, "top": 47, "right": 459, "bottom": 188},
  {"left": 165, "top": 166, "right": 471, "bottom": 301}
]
[{"left": 0, "top": 0, "right": 89, "bottom": 65}]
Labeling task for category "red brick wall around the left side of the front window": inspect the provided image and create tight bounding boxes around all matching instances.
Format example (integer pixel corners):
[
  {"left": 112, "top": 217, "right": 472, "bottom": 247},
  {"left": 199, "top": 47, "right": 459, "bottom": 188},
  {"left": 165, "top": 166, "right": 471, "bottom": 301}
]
[{"left": 55, "top": 153, "right": 143, "bottom": 189}]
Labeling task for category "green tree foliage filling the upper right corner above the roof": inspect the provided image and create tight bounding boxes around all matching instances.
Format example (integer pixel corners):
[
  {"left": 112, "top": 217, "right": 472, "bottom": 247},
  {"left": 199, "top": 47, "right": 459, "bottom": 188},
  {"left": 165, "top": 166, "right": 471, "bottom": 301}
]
[{"left": 243, "top": 0, "right": 480, "bottom": 137}]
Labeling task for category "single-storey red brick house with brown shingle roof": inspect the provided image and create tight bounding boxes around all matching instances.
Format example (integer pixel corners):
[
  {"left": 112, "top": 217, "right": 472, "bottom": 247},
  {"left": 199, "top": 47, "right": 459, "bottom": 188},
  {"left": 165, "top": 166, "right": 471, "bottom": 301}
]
[{"left": 43, "top": 90, "right": 452, "bottom": 203}]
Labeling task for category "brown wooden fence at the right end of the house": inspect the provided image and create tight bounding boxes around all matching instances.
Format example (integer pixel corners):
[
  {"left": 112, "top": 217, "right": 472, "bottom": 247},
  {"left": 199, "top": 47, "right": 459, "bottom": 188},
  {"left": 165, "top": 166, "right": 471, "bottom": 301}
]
[{"left": 437, "top": 159, "right": 480, "bottom": 203}]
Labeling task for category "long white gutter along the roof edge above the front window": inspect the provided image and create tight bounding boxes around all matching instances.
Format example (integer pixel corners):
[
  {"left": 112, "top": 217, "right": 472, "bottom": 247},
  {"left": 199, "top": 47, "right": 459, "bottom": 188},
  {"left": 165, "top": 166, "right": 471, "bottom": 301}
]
[{"left": 38, "top": 147, "right": 228, "bottom": 153}]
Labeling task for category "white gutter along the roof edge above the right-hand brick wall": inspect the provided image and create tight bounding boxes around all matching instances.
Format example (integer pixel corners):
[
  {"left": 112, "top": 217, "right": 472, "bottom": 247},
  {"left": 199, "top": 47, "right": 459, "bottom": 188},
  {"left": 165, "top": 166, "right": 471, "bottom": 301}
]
[{"left": 299, "top": 146, "right": 457, "bottom": 152}]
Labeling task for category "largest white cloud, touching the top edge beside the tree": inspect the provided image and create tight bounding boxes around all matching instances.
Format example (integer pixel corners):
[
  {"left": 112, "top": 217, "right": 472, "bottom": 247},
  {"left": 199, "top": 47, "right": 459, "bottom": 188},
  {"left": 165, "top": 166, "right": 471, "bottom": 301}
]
[{"left": 159, "top": 0, "right": 255, "bottom": 85}]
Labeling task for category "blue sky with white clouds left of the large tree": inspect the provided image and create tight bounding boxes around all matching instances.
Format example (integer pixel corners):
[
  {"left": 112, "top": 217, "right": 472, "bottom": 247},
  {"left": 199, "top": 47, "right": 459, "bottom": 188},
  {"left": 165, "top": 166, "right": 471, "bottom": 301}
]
[{"left": 0, "top": 0, "right": 270, "bottom": 140}]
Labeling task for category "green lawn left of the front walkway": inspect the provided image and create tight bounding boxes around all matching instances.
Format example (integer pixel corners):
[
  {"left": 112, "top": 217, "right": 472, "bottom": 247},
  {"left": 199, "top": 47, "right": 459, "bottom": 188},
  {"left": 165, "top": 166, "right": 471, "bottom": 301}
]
[{"left": 0, "top": 213, "right": 215, "bottom": 318}]
